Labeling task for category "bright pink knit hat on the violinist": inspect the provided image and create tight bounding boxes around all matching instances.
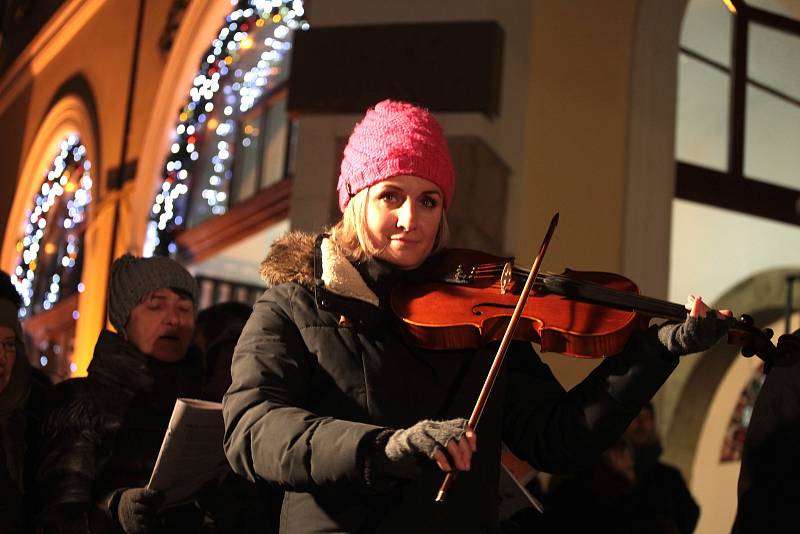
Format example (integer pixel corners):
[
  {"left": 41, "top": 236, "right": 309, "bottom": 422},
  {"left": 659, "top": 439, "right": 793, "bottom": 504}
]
[{"left": 336, "top": 100, "right": 456, "bottom": 212}]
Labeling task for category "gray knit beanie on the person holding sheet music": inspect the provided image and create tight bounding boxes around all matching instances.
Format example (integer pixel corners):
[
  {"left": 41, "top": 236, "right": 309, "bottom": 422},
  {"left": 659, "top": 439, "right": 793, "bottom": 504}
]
[{"left": 108, "top": 254, "right": 197, "bottom": 334}]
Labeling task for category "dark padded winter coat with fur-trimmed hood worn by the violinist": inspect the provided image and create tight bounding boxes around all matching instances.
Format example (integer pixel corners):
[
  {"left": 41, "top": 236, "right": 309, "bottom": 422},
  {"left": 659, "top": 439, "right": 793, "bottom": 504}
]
[{"left": 223, "top": 234, "right": 677, "bottom": 534}]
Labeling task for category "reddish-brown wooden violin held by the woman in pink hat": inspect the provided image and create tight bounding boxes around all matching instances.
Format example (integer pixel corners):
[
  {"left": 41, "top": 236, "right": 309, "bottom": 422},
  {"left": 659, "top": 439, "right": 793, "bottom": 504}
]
[{"left": 391, "top": 249, "right": 800, "bottom": 365}]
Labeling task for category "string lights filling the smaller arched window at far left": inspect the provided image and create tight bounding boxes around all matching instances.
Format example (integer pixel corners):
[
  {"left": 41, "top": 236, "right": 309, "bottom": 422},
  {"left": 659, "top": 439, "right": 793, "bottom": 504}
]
[{"left": 11, "top": 135, "right": 92, "bottom": 318}]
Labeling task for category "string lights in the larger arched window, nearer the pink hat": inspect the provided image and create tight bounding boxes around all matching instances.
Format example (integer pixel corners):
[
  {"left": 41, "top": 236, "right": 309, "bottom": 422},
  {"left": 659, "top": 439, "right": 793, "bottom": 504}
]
[{"left": 143, "top": 0, "right": 310, "bottom": 256}]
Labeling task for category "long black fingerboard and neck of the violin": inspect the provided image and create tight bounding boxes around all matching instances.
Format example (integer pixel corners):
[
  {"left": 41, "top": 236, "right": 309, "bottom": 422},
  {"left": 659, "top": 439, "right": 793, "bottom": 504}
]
[{"left": 538, "top": 275, "right": 687, "bottom": 321}]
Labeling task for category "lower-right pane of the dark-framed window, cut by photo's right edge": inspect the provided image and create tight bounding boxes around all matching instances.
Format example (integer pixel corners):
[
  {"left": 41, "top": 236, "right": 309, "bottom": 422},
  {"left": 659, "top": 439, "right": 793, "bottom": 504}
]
[{"left": 744, "top": 85, "right": 800, "bottom": 189}]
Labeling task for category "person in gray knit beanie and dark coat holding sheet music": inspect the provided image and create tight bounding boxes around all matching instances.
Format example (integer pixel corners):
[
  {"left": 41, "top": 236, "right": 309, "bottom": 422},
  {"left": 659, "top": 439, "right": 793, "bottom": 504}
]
[{"left": 39, "top": 255, "right": 209, "bottom": 533}]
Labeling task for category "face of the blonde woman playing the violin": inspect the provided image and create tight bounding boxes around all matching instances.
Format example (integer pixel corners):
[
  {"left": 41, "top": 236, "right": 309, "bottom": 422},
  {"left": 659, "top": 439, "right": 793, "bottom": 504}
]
[{"left": 367, "top": 175, "right": 443, "bottom": 269}]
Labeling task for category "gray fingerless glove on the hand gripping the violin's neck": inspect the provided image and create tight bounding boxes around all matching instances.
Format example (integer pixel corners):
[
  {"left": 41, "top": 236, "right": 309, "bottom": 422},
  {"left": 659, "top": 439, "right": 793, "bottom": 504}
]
[{"left": 651, "top": 310, "right": 734, "bottom": 356}]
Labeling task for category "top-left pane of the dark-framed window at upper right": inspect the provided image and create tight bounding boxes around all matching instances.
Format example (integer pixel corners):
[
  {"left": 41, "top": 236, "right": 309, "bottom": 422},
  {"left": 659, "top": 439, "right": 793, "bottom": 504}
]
[{"left": 681, "top": 0, "right": 733, "bottom": 67}]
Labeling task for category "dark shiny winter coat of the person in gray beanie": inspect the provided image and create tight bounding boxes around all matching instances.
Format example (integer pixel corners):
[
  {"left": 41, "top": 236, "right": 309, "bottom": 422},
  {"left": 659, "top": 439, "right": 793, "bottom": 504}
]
[{"left": 37, "top": 331, "right": 203, "bottom": 533}]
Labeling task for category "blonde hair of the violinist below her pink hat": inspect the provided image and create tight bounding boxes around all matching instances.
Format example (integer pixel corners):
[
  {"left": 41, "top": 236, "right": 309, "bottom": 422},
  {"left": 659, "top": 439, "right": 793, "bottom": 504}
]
[{"left": 327, "top": 187, "right": 450, "bottom": 262}]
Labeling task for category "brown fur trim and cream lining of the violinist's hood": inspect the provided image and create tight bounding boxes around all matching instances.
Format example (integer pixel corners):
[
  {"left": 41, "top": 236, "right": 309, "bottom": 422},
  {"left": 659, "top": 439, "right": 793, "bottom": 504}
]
[{"left": 260, "top": 232, "right": 379, "bottom": 306}]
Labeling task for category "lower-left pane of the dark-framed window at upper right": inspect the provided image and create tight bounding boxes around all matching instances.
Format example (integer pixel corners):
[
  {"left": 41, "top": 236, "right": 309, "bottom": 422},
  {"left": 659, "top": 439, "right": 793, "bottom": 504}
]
[{"left": 675, "top": 54, "right": 730, "bottom": 171}]
